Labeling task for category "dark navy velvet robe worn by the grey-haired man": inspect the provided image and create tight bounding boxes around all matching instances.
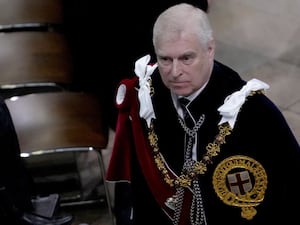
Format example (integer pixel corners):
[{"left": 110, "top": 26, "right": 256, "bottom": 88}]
[{"left": 110, "top": 62, "right": 300, "bottom": 225}]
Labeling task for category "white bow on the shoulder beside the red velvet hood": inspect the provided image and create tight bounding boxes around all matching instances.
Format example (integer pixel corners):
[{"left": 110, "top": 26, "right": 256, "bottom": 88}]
[{"left": 134, "top": 55, "right": 157, "bottom": 127}]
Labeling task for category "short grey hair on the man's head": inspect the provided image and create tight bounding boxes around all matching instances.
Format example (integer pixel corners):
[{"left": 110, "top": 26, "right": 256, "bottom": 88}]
[{"left": 152, "top": 3, "right": 214, "bottom": 48}]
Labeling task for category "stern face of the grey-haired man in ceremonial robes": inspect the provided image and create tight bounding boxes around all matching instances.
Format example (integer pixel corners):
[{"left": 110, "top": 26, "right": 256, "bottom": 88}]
[{"left": 156, "top": 34, "right": 215, "bottom": 96}]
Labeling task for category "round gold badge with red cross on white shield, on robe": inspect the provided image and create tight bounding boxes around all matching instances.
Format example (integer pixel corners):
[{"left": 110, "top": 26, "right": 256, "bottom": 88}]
[{"left": 213, "top": 155, "right": 268, "bottom": 220}]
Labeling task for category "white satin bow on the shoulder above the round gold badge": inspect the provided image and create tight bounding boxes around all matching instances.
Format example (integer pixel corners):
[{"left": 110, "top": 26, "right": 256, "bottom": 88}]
[{"left": 218, "top": 78, "right": 270, "bottom": 128}]
